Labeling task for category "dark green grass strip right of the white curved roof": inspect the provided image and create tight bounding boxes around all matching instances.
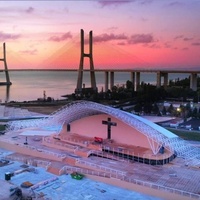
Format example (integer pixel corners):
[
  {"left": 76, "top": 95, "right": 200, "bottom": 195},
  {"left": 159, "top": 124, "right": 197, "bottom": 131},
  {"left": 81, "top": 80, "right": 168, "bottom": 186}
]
[{"left": 167, "top": 128, "right": 200, "bottom": 141}]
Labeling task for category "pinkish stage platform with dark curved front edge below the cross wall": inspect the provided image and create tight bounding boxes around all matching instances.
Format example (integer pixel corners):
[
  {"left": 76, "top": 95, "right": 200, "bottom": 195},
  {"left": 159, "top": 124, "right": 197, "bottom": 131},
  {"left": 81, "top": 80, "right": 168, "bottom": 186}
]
[{"left": 43, "top": 133, "right": 175, "bottom": 165}]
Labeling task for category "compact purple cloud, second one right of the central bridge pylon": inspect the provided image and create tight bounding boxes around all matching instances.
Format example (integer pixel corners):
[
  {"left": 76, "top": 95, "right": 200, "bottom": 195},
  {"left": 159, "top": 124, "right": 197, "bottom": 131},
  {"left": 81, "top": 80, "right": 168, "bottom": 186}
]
[{"left": 128, "top": 34, "right": 154, "bottom": 44}]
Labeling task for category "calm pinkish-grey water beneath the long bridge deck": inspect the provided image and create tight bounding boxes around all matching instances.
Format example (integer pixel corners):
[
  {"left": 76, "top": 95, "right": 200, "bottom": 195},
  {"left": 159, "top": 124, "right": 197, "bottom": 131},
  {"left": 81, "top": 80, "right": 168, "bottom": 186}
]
[{"left": 0, "top": 71, "right": 189, "bottom": 102}]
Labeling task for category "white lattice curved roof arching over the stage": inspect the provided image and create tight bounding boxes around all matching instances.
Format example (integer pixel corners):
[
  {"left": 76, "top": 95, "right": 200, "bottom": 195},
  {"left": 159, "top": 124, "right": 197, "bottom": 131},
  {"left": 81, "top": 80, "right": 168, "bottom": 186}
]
[{"left": 6, "top": 101, "right": 200, "bottom": 165}]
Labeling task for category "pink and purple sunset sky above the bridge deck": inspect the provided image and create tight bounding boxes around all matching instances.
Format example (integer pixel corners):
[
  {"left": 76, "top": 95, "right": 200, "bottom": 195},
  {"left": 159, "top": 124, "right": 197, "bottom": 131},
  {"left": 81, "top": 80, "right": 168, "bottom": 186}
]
[{"left": 0, "top": 0, "right": 200, "bottom": 69}]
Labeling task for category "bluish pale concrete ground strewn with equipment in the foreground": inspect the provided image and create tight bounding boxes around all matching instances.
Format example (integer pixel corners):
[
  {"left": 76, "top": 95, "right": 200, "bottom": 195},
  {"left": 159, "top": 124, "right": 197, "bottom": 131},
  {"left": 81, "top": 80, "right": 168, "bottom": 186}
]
[{"left": 0, "top": 149, "right": 159, "bottom": 200}]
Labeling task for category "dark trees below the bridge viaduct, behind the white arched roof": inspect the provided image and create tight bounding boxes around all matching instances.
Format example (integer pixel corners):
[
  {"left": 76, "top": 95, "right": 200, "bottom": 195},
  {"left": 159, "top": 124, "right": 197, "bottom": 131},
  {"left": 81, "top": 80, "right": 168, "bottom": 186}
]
[{"left": 70, "top": 78, "right": 200, "bottom": 117}]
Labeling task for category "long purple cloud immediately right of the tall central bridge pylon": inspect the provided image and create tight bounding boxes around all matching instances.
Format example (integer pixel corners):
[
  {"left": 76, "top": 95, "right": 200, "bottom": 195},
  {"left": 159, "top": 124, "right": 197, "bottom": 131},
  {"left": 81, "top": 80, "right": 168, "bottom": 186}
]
[{"left": 94, "top": 33, "right": 127, "bottom": 42}]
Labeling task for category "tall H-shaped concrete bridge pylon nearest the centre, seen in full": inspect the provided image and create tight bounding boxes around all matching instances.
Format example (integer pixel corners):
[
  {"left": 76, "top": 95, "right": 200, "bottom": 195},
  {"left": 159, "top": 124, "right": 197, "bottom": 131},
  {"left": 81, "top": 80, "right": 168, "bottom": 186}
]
[{"left": 75, "top": 29, "right": 97, "bottom": 94}]
